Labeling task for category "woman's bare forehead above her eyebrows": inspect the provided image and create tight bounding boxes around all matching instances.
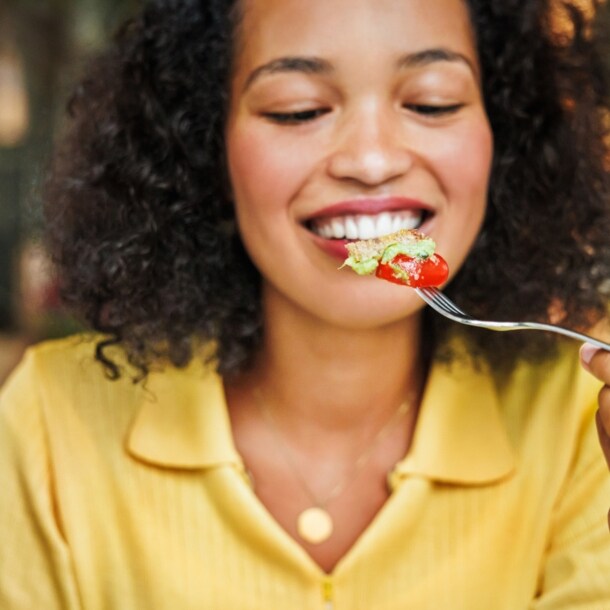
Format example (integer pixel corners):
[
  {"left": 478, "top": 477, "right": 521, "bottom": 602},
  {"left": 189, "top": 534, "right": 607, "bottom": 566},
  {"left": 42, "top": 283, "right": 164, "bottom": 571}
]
[{"left": 237, "top": 0, "right": 477, "bottom": 69}]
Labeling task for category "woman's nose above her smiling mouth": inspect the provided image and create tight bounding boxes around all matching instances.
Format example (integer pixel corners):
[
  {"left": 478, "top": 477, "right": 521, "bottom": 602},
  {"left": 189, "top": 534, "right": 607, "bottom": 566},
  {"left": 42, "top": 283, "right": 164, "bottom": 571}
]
[{"left": 328, "top": 102, "right": 413, "bottom": 186}]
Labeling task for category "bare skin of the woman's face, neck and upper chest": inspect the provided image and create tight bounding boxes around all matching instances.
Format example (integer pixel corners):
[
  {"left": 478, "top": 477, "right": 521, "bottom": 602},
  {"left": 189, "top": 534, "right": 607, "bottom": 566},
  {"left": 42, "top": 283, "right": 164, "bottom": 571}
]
[{"left": 226, "top": 0, "right": 492, "bottom": 571}]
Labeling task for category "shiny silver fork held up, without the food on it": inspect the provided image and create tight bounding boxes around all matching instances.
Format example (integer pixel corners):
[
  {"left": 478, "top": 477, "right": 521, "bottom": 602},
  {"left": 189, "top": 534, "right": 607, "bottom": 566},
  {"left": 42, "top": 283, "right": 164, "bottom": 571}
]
[{"left": 415, "top": 288, "right": 610, "bottom": 351}]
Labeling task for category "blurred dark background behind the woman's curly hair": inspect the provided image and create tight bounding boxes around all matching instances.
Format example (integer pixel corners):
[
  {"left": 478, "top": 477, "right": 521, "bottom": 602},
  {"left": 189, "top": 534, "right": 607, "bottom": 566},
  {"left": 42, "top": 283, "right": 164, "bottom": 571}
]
[{"left": 0, "top": 0, "right": 610, "bottom": 385}]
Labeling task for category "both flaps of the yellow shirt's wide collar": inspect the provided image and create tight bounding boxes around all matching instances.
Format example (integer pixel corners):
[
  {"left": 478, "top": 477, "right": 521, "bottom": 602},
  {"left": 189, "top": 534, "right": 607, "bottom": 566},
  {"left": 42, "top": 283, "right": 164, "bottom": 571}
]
[{"left": 126, "top": 350, "right": 515, "bottom": 485}]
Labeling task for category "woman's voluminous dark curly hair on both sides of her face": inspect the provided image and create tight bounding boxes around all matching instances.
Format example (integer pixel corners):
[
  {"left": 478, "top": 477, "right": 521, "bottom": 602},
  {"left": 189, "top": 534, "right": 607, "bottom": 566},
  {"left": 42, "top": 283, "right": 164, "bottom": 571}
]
[{"left": 45, "top": 0, "right": 610, "bottom": 377}]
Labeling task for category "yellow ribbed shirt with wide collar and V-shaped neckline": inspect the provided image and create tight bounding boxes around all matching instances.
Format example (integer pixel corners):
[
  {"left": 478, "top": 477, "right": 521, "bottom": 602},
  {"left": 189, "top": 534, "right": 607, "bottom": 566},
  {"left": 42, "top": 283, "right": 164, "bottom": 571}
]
[{"left": 0, "top": 338, "right": 610, "bottom": 610}]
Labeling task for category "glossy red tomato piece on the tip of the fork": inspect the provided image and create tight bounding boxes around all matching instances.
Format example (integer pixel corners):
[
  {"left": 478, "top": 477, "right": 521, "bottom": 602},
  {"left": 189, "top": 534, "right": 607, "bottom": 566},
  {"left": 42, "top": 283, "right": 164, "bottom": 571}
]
[{"left": 375, "top": 254, "right": 449, "bottom": 288}]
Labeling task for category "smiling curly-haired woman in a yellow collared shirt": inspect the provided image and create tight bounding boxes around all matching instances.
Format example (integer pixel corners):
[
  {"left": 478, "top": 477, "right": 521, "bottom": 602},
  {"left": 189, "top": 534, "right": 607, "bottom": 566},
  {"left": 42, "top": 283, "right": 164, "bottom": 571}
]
[{"left": 0, "top": 0, "right": 610, "bottom": 610}]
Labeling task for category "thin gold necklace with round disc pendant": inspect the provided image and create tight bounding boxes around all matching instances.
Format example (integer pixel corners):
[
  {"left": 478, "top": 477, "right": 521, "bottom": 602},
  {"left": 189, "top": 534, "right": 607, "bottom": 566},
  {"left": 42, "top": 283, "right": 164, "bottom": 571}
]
[{"left": 249, "top": 388, "right": 413, "bottom": 544}]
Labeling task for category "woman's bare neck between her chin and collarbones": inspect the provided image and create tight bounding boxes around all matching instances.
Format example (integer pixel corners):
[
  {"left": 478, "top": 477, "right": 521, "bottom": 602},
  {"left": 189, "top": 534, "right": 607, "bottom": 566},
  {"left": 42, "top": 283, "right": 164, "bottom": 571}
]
[{"left": 242, "top": 284, "right": 423, "bottom": 435}]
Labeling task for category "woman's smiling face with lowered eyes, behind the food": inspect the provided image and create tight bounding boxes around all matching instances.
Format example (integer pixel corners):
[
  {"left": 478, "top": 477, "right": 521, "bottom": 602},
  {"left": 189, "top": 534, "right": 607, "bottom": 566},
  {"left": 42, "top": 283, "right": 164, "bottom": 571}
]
[{"left": 226, "top": 0, "right": 492, "bottom": 328}]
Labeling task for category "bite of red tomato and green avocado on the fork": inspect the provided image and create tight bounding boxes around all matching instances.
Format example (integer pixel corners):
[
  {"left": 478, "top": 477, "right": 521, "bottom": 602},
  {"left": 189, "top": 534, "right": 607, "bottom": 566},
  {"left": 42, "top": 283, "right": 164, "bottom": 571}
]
[{"left": 343, "top": 229, "right": 449, "bottom": 288}]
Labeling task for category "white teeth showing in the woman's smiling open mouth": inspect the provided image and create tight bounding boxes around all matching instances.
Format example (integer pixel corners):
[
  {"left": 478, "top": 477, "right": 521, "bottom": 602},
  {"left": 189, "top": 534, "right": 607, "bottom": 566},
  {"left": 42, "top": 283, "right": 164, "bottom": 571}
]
[{"left": 307, "top": 209, "right": 429, "bottom": 240}]
